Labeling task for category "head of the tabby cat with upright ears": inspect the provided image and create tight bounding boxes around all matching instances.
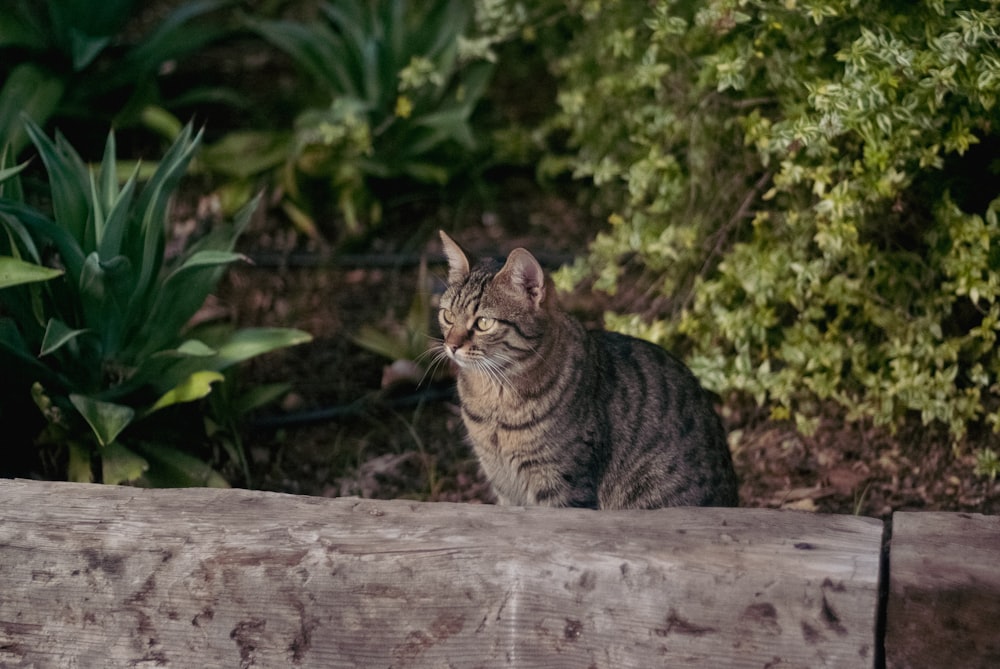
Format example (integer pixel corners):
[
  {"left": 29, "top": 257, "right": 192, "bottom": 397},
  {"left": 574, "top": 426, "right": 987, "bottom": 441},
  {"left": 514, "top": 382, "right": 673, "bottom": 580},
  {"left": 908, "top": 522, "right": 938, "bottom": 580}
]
[{"left": 438, "top": 231, "right": 555, "bottom": 373}]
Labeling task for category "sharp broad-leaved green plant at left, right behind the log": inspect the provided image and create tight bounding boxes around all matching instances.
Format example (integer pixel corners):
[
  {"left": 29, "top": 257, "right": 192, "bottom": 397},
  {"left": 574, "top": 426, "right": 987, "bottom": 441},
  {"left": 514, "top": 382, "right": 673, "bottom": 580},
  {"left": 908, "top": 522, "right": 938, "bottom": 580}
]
[{"left": 0, "top": 120, "right": 309, "bottom": 485}]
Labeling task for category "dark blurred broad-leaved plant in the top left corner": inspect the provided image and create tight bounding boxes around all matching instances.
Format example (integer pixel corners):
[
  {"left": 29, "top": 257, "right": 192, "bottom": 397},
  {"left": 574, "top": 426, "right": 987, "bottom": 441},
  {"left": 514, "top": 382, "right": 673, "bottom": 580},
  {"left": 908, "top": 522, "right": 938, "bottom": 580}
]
[{"left": 0, "top": 0, "right": 239, "bottom": 156}]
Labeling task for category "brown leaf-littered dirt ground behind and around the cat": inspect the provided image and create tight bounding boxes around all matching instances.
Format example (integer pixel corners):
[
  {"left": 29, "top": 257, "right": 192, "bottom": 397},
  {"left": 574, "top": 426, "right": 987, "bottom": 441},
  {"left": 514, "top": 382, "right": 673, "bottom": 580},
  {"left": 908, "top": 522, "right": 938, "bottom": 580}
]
[{"left": 211, "top": 177, "right": 1000, "bottom": 517}]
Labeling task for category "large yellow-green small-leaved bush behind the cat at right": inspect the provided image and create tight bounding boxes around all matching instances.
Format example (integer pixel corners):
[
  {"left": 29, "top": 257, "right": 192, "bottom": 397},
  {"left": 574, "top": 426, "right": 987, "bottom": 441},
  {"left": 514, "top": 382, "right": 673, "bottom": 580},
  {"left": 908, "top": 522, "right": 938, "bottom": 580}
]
[{"left": 555, "top": 0, "right": 1000, "bottom": 440}]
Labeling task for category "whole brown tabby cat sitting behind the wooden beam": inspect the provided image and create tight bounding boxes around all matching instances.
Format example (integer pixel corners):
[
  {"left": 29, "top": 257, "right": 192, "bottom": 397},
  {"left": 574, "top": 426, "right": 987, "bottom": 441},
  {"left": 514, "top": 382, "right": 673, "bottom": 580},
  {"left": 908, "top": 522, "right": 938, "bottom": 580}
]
[{"left": 439, "top": 231, "right": 738, "bottom": 509}]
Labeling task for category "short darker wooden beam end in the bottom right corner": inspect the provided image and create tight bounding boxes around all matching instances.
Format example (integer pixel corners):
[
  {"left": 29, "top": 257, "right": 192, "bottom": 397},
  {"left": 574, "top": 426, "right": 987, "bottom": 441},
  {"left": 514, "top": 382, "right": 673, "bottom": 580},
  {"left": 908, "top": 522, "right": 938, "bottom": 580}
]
[{"left": 885, "top": 513, "right": 1000, "bottom": 669}]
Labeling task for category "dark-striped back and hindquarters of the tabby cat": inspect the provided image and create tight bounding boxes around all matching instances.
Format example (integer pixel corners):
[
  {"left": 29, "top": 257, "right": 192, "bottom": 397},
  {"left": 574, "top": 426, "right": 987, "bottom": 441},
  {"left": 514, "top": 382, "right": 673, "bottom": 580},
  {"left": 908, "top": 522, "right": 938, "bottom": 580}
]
[{"left": 587, "top": 330, "right": 738, "bottom": 508}]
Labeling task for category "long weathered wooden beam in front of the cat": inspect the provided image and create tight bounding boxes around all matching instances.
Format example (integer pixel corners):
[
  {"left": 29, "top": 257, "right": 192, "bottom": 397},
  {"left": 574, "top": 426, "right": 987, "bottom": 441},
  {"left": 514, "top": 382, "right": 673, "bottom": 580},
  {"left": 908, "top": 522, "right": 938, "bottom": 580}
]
[{"left": 0, "top": 481, "right": 882, "bottom": 669}]
